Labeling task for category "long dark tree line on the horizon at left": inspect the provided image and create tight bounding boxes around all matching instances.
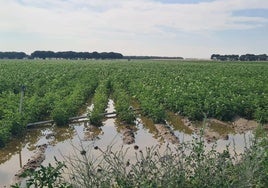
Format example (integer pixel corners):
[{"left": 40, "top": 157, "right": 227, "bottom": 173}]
[{"left": 0, "top": 51, "right": 123, "bottom": 59}]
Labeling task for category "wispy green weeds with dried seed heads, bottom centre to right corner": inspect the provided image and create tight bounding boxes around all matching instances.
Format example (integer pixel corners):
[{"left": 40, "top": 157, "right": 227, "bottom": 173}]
[{"left": 67, "top": 127, "right": 268, "bottom": 187}]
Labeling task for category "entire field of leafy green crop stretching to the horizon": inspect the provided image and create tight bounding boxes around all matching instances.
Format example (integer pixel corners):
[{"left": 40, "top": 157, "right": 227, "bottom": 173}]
[{"left": 0, "top": 60, "right": 268, "bottom": 146}]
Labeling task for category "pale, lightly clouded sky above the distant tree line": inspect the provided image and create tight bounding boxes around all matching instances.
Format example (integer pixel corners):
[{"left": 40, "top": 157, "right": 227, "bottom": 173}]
[{"left": 0, "top": 0, "right": 268, "bottom": 58}]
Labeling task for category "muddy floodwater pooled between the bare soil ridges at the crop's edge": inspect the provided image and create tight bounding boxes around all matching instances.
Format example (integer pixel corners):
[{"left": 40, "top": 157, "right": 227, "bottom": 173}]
[{"left": 0, "top": 100, "right": 252, "bottom": 187}]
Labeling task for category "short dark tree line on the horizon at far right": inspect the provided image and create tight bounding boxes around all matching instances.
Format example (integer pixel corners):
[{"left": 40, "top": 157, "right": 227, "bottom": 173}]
[{"left": 210, "top": 54, "right": 268, "bottom": 61}]
